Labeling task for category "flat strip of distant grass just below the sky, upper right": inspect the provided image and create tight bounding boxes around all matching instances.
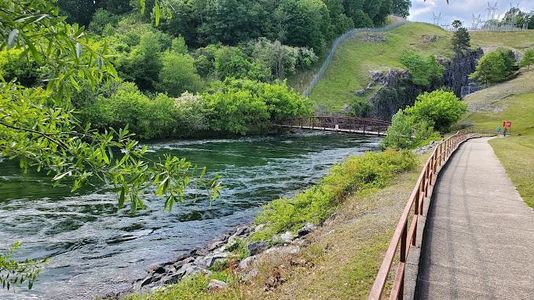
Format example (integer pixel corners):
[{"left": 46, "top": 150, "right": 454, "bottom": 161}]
[{"left": 470, "top": 30, "right": 534, "bottom": 50}]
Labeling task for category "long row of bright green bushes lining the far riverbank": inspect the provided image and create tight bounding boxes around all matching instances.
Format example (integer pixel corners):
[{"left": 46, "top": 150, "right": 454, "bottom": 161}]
[{"left": 80, "top": 79, "right": 311, "bottom": 139}]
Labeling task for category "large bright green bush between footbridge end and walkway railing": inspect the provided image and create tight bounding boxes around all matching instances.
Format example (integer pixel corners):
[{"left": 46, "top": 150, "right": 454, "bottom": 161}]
[{"left": 382, "top": 90, "right": 467, "bottom": 149}]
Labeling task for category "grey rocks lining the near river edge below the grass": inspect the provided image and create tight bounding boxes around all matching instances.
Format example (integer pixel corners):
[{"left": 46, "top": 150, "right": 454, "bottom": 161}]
[{"left": 105, "top": 220, "right": 316, "bottom": 299}]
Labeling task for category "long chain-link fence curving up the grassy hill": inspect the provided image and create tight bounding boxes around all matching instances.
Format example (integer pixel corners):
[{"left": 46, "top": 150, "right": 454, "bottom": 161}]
[{"left": 303, "top": 18, "right": 407, "bottom": 97}]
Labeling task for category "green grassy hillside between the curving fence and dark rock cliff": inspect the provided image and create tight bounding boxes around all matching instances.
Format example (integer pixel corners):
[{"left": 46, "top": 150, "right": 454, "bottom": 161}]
[{"left": 310, "top": 23, "right": 452, "bottom": 111}]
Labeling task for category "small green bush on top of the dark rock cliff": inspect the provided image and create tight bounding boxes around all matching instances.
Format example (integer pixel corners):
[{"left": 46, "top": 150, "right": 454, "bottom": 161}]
[{"left": 400, "top": 52, "right": 445, "bottom": 86}]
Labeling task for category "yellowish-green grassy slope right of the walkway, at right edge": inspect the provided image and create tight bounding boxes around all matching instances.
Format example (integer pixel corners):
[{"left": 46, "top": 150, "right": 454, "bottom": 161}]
[{"left": 464, "top": 71, "right": 534, "bottom": 207}]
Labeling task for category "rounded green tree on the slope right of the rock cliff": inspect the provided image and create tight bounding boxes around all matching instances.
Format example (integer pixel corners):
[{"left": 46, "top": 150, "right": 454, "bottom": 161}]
[{"left": 471, "top": 48, "right": 518, "bottom": 84}]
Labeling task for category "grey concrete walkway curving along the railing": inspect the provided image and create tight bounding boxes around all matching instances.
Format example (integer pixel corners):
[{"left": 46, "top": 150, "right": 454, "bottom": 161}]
[{"left": 415, "top": 139, "right": 534, "bottom": 299}]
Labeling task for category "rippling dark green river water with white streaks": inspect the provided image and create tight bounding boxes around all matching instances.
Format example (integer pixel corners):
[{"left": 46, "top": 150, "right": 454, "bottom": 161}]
[{"left": 0, "top": 133, "right": 379, "bottom": 299}]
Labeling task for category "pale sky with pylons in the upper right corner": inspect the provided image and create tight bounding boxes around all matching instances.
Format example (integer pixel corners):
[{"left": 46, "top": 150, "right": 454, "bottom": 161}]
[{"left": 408, "top": 0, "right": 534, "bottom": 27}]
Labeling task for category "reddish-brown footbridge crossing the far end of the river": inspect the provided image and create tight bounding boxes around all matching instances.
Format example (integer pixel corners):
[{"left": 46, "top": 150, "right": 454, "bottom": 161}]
[{"left": 279, "top": 116, "right": 391, "bottom": 136}]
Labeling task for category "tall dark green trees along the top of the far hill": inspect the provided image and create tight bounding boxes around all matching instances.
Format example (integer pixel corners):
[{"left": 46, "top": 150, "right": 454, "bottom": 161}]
[{"left": 59, "top": 0, "right": 404, "bottom": 53}]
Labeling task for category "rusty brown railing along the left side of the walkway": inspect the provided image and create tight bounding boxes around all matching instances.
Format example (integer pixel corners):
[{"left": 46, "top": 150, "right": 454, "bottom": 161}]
[{"left": 368, "top": 132, "right": 481, "bottom": 299}]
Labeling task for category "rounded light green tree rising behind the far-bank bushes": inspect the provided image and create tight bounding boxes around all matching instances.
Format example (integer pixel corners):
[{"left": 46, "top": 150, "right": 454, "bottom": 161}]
[{"left": 159, "top": 51, "right": 202, "bottom": 97}]
